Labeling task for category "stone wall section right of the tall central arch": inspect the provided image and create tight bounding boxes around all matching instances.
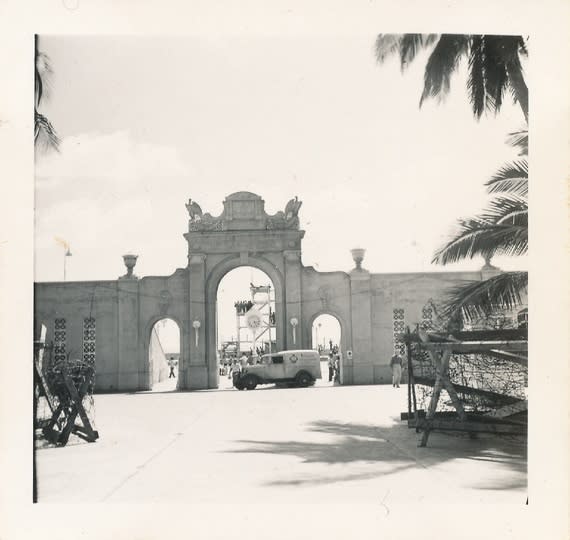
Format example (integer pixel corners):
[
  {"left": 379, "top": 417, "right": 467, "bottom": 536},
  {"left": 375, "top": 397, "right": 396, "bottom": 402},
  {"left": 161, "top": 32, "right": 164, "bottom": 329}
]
[{"left": 296, "top": 267, "right": 482, "bottom": 384}]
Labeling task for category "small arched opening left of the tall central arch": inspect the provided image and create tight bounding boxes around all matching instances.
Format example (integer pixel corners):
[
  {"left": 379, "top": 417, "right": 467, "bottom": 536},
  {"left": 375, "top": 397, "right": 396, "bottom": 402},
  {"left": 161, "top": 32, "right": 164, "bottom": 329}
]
[{"left": 148, "top": 318, "right": 180, "bottom": 392}]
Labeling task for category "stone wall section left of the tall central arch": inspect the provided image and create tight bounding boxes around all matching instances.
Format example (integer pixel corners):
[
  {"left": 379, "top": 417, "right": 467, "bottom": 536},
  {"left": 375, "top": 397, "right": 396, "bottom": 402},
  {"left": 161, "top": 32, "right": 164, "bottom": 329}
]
[{"left": 34, "top": 270, "right": 189, "bottom": 392}]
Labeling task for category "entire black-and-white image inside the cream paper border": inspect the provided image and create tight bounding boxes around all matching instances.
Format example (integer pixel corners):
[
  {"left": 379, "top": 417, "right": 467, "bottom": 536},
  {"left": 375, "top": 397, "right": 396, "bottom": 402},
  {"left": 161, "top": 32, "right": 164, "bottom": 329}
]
[{"left": 30, "top": 33, "right": 532, "bottom": 505}]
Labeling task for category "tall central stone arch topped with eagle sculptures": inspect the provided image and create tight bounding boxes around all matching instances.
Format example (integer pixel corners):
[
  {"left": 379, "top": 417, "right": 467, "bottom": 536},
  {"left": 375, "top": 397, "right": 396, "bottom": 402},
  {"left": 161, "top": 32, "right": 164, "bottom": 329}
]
[{"left": 184, "top": 192, "right": 305, "bottom": 388}]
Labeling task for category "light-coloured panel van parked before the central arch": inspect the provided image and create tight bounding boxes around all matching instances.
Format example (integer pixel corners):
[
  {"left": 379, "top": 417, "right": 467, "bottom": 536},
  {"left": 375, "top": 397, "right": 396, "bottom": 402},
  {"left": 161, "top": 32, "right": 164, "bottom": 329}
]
[{"left": 233, "top": 350, "right": 322, "bottom": 390}]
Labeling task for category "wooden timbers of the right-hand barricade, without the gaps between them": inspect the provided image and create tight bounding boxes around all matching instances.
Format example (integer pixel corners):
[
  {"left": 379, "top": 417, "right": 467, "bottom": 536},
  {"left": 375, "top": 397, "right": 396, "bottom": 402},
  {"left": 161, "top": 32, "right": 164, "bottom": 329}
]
[{"left": 402, "top": 327, "right": 528, "bottom": 446}]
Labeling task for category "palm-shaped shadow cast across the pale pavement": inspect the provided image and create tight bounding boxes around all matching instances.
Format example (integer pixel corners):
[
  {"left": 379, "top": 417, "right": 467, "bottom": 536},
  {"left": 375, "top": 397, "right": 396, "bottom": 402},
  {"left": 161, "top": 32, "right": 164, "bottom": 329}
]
[{"left": 222, "top": 421, "right": 527, "bottom": 490}]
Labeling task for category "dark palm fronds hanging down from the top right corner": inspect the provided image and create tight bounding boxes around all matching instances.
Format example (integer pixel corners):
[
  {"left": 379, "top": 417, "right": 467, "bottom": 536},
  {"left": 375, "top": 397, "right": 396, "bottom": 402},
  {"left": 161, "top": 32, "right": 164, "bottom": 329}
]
[{"left": 376, "top": 34, "right": 528, "bottom": 121}]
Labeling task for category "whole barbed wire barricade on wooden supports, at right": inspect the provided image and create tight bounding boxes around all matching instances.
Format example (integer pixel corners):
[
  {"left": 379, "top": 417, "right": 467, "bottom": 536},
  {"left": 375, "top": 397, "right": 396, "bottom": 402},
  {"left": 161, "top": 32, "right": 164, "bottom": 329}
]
[{"left": 403, "top": 327, "right": 528, "bottom": 446}]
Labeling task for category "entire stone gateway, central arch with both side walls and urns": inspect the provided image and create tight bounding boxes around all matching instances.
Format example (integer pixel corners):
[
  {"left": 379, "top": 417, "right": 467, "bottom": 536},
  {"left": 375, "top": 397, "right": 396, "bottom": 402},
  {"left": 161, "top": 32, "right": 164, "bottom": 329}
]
[{"left": 35, "top": 192, "right": 497, "bottom": 392}]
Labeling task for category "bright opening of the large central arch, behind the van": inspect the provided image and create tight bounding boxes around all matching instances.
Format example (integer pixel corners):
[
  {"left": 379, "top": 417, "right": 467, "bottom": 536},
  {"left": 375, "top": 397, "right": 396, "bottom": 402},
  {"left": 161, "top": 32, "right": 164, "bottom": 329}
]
[{"left": 216, "top": 266, "right": 277, "bottom": 389}]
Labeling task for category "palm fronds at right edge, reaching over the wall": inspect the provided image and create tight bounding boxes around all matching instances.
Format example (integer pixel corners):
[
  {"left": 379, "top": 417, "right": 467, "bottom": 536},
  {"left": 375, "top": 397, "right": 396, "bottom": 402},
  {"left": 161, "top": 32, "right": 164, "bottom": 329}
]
[{"left": 432, "top": 131, "right": 528, "bottom": 320}]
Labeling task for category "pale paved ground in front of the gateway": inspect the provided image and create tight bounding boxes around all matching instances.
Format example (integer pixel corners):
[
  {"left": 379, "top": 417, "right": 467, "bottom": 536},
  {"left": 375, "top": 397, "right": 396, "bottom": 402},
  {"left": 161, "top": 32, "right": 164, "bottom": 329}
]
[{"left": 37, "top": 380, "right": 527, "bottom": 505}]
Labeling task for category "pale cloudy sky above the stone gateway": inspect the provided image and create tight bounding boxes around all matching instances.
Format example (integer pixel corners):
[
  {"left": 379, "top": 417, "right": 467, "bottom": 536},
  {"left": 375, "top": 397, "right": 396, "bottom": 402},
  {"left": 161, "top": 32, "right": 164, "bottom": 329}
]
[{"left": 35, "top": 34, "right": 524, "bottom": 346}]
